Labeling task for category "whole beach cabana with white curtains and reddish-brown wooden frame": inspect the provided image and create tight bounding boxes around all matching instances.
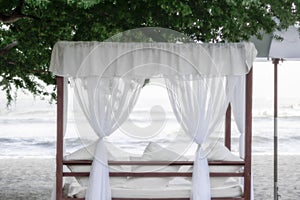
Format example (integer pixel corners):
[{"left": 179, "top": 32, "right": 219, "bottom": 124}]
[{"left": 50, "top": 41, "right": 256, "bottom": 200}]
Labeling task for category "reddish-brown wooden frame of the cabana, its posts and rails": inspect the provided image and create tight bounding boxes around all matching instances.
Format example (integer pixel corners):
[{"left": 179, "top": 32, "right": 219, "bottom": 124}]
[{"left": 56, "top": 69, "right": 253, "bottom": 200}]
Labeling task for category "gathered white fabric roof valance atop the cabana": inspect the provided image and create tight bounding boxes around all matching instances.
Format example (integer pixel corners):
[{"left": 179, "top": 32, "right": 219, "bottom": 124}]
[{"left": 50, "top": 41, "right": 257, "bottom": 77}]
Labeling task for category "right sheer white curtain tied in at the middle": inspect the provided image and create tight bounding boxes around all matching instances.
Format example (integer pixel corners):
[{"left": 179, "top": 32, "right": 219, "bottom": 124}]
[{"left": 166, "top": 76, "right": 228, "bottom": 200}]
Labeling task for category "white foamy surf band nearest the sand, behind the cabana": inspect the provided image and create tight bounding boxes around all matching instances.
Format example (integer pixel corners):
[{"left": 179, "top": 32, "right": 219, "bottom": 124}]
[{"left": 0, "top": 131, "right": 300, "bottom": 157}]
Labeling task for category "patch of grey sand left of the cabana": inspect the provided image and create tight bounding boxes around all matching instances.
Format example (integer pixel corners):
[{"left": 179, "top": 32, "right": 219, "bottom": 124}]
[{"left": 0, "top": 158, "right": 55, "bottom": 200}]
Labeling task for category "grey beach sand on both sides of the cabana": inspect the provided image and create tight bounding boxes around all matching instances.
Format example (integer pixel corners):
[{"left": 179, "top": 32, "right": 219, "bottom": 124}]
[{"left": 0, "top": 155, "right": 300, "bottom": 200}]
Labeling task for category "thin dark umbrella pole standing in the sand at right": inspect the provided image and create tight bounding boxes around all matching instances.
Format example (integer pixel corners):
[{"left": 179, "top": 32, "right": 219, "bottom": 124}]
[{"left": 273, "top": 58, "right": 279, "bottom": 200}]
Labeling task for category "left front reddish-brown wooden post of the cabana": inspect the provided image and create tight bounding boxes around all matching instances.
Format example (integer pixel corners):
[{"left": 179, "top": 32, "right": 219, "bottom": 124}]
[{"left": 56, "top": 76, "right": 64, "bottom": 200}]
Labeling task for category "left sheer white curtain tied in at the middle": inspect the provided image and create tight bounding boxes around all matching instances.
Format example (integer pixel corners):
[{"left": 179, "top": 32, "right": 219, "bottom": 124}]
[{"left": 74, "top": 76, "right": 144, "bottom": 200}]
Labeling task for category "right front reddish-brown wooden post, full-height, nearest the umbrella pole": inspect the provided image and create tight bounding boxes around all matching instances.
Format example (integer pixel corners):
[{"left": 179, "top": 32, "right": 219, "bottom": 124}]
[{"left": 244, "top": 67, "right": 253, "bottom": 200}]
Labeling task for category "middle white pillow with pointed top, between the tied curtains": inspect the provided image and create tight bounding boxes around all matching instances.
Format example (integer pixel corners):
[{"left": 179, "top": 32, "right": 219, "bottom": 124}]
[{"left": 124, "top": 142, "right": 186, "bottom": 189}]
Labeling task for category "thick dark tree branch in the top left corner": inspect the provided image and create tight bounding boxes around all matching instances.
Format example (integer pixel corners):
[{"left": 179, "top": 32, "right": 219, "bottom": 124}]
[{"left": 0, "top": 0, "right": 39, "bottom": 24}]
